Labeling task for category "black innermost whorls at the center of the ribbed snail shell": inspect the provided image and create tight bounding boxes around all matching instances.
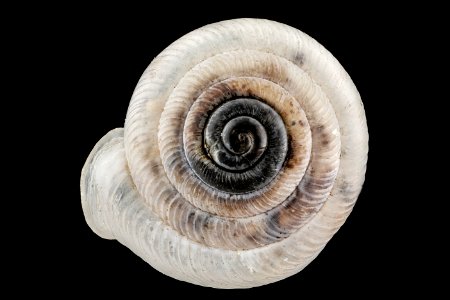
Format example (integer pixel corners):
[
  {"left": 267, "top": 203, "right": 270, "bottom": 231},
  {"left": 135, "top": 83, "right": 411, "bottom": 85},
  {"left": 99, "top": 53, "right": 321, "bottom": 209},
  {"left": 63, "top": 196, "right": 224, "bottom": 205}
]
[{"left": 192, "top": 98, "right": 288, "bottom": 193}]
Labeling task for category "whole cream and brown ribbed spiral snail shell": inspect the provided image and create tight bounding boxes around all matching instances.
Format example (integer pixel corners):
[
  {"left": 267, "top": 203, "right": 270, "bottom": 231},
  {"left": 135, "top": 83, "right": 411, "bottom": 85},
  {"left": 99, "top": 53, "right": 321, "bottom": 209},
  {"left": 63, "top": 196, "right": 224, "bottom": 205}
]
[{"left": 81, "top": 19, "right": 368, "bottom": 288}]
